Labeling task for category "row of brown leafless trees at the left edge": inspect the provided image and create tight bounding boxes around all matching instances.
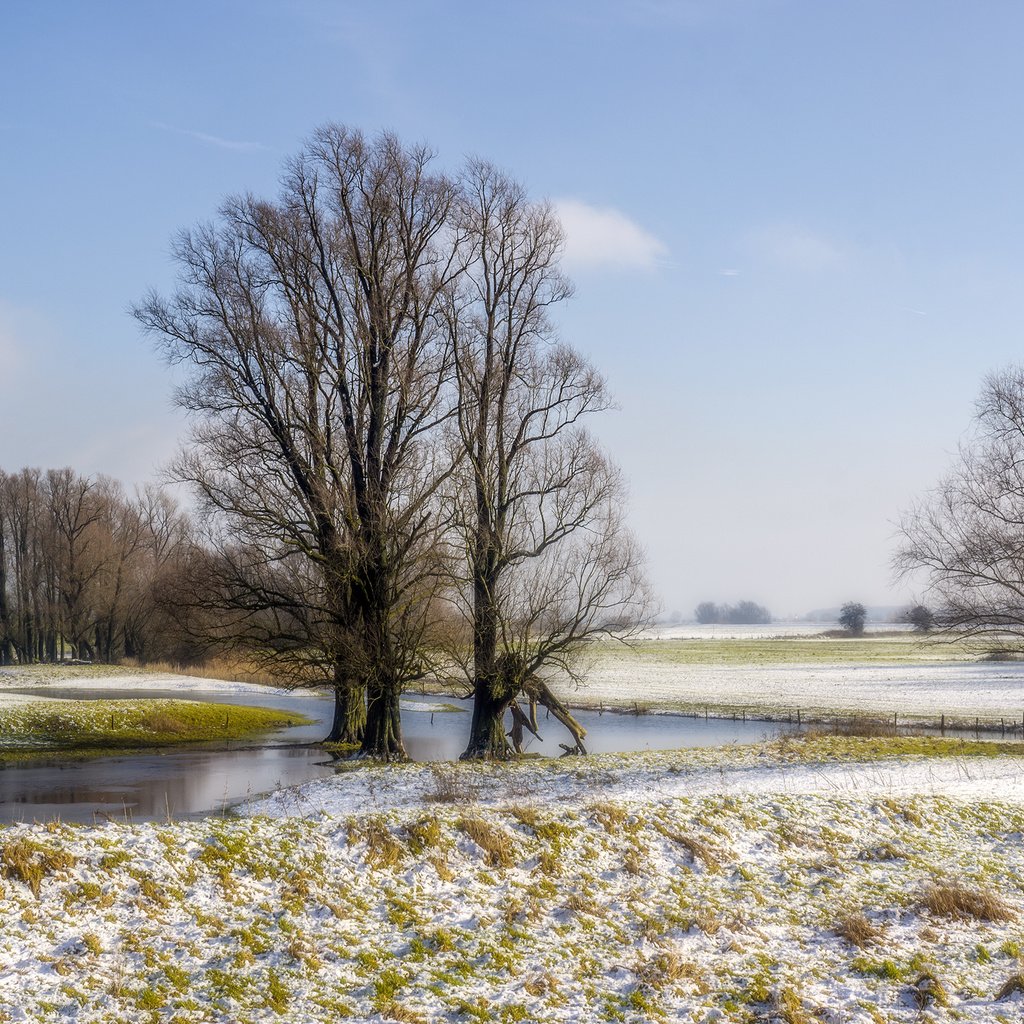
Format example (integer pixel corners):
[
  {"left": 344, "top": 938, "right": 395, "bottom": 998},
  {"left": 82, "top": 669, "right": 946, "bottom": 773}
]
[{"left": 0, "top": 469, "right": 193, "bottom": 665}]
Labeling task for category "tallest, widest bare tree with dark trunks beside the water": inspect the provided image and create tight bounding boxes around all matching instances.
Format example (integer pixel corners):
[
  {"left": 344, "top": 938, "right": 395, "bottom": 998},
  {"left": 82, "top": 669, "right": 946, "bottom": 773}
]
[{"left": 136, "top": 125, "right": 460, "bottom": 759}]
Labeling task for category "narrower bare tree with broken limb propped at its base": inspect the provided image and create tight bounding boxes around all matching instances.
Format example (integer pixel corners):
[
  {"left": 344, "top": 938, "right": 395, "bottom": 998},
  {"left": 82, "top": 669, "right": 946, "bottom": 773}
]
[{"left": 449, "top": 162, "right": 648, "bottom": 758}]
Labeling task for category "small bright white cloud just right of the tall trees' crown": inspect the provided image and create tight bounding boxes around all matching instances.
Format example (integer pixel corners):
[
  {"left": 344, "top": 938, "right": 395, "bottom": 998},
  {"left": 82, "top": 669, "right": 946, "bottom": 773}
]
[{"left": 555, "top": 199, "right": 669, "bottom": 270}]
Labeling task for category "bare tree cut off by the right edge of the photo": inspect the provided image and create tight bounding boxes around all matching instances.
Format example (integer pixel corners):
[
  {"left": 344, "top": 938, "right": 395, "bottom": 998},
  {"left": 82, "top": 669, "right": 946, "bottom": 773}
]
[{"left": 895, "top": 367, "right": 1024, "bottom": 637}]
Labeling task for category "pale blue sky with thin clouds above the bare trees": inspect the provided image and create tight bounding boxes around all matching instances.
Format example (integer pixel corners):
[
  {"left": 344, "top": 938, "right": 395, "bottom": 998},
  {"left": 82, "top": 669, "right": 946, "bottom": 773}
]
[{"left": 0, "top": 0, "right": 1024, "bottom": 614}]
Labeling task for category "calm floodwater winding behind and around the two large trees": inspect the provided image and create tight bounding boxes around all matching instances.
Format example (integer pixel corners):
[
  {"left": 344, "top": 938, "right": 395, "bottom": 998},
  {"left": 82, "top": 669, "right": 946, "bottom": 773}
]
[{"left": 0, "top": 686, "right": 788, "bottom": 822}]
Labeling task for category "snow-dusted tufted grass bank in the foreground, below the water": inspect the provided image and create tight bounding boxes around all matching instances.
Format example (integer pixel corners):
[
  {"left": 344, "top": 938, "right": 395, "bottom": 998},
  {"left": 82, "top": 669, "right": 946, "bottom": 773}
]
[{"left": 6, "top": 739, "right": 1024, "bottom": 1024}]
